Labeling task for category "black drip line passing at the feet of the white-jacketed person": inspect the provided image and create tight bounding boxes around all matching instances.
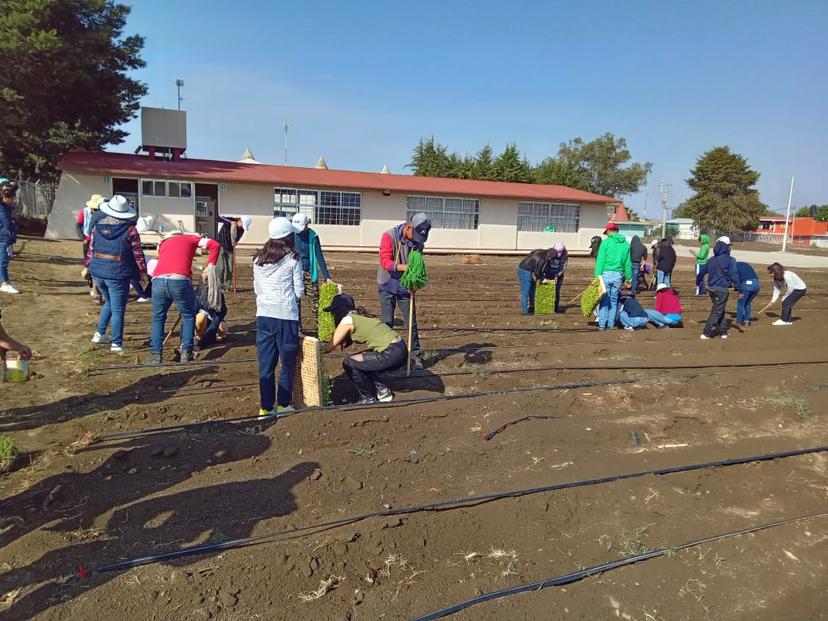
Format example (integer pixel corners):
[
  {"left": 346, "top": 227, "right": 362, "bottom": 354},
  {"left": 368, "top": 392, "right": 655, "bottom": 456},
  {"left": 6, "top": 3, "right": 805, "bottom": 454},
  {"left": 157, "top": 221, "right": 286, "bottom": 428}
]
[{"left": 94, "top": 361, "right": 825, "bottom": 442}]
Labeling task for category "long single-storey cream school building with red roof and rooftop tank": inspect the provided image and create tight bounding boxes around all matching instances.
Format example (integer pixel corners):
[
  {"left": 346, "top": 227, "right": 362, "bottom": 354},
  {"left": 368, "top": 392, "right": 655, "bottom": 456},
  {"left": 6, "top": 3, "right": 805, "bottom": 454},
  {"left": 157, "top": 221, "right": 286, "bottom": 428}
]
[{"left": 46, "top": 108, "right": 616, "bottom": 253}]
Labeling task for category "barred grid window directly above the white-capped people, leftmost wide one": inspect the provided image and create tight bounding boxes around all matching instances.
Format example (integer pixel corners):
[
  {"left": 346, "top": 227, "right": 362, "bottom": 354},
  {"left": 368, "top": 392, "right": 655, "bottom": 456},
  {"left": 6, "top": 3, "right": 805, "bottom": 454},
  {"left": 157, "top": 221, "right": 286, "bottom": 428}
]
[{"left": 273, "top": 188, "right": 362, "bottom": 226}]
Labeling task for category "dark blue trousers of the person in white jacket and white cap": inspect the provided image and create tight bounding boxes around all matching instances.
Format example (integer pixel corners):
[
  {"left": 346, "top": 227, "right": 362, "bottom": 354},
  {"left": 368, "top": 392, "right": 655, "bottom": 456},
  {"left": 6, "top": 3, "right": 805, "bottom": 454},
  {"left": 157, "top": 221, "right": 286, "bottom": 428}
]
[{"left": 256, "top": 317, "right": 299, "bottom": 412}]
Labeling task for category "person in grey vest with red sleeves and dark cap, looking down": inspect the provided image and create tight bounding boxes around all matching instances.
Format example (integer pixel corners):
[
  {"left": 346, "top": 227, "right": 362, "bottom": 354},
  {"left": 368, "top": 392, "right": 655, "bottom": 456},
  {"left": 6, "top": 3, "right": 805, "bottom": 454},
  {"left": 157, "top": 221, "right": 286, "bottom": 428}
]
[{"left": 377, "top": 213, "right": 431, "bottom": 368}]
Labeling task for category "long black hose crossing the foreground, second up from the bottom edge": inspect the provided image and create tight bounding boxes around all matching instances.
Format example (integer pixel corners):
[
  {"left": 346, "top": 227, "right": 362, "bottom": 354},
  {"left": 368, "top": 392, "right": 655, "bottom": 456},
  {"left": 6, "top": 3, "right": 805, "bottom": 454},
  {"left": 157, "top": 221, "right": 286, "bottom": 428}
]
[{"left": 85, "top": 446, "right": 828, "bottom": 576}]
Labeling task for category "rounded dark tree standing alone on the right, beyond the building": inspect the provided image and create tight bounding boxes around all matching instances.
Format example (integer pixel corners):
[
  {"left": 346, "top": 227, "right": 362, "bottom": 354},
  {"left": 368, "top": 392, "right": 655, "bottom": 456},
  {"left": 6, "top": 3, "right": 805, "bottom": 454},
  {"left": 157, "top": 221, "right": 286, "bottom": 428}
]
[{"left": 676, "top": 147, "right": 767, "bottom": 231}]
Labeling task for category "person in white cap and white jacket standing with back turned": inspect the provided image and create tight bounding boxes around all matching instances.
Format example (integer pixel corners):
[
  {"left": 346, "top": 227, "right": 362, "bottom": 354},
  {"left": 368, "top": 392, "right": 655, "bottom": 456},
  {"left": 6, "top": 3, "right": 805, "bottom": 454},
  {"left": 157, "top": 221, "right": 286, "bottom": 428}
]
[{"left": 253, "top": 218, "right": 305, "bottom": 419}]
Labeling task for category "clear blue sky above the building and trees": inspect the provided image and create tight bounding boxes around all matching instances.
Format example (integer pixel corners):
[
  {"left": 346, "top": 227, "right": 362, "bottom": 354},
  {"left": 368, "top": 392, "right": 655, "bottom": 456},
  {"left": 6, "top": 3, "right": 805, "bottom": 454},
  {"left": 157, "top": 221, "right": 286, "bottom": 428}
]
[{"left": 117, "top": 0, "right": 828, "bottom": 216}]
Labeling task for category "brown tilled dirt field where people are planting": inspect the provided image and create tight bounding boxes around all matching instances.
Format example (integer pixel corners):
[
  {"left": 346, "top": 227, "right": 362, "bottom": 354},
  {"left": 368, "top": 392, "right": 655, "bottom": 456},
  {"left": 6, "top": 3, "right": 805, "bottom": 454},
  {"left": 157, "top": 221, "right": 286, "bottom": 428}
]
[{"left": 0, "top": 239, "right": 828, "bottom": 621}]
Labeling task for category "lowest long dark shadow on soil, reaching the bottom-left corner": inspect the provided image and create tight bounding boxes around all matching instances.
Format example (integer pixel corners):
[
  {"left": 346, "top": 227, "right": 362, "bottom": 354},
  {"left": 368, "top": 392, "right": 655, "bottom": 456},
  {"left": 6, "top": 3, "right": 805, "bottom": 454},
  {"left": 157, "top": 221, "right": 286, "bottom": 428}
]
[{"left": 0, "top": 436, "right": 318, "bottom": 618}]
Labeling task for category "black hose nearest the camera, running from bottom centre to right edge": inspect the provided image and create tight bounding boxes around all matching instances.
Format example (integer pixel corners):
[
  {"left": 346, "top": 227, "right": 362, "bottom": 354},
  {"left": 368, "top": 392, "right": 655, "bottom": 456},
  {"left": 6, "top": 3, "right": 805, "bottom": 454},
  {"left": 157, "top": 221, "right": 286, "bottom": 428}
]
[{"left": 413, "top": 513, "right": 828, "bottom": 621}]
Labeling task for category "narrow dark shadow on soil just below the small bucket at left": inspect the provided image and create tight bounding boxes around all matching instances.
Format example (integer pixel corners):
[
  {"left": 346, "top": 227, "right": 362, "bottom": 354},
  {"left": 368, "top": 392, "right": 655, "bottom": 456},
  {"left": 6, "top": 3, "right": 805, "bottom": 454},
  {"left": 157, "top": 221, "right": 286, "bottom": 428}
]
[{"left": 0, "top": 367, "right": 217, "bottom": 432}]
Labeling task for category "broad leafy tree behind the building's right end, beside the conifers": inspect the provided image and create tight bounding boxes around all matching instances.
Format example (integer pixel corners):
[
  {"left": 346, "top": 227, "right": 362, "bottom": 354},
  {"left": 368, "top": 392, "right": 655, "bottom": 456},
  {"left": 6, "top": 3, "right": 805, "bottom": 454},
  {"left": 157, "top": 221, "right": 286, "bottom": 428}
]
[{"left": 555, "top": 133, "right": 653, "bottom": 197}]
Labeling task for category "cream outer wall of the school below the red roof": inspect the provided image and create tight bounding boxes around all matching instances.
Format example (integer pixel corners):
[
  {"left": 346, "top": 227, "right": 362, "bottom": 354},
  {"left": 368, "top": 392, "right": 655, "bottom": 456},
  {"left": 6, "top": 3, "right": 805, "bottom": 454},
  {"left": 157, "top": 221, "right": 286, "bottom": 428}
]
[{"left": 47, "top": 172, "right": 607, "bottom": 252}]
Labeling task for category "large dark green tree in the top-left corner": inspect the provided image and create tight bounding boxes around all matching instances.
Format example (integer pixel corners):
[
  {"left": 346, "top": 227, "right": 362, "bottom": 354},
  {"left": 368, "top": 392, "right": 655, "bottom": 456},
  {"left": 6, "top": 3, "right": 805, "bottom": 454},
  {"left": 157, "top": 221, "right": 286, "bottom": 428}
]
[{"left": 0, "top": 0, "right": 146, "bottom": 179}]
